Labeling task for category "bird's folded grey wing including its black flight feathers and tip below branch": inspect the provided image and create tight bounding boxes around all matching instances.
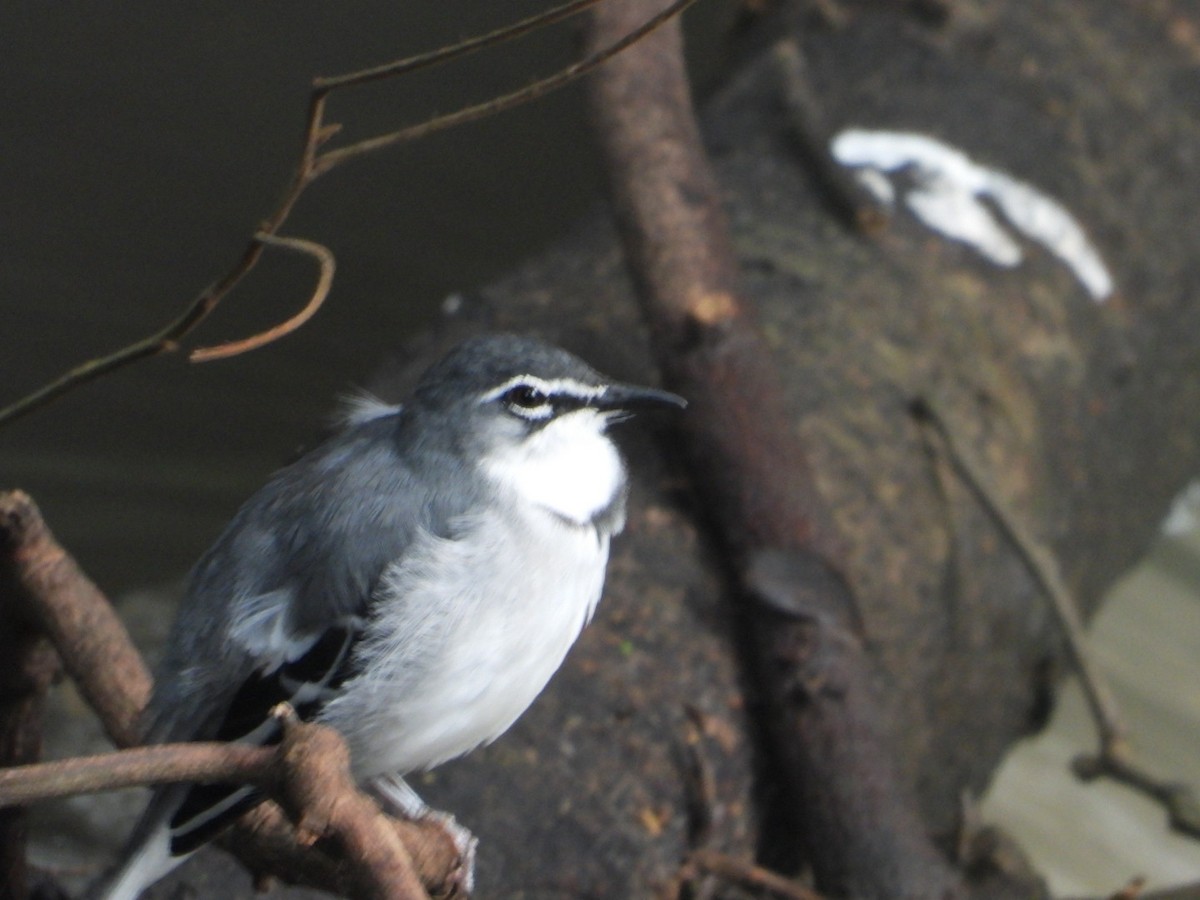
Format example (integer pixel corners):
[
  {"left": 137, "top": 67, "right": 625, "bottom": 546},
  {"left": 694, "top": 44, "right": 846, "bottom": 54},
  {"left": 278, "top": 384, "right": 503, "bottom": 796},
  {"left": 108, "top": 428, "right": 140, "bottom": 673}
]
[{"left": 137, "top": 419, "right": 458, "bottom": 854}]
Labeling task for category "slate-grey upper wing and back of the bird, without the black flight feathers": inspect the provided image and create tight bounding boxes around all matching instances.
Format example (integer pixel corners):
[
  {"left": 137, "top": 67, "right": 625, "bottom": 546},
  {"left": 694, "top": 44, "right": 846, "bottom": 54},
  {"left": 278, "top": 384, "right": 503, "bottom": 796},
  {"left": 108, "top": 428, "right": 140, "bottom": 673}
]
[{"left": 146, "top": 416, "right": 430, "bottom": 743}]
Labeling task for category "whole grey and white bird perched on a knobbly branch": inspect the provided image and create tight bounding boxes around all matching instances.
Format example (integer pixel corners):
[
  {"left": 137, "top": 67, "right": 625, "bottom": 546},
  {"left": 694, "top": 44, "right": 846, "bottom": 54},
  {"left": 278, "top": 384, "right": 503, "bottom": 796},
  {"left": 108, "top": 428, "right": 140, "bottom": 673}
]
[{"left": 92, "top": 335, "right": 685, "bottom": 900}]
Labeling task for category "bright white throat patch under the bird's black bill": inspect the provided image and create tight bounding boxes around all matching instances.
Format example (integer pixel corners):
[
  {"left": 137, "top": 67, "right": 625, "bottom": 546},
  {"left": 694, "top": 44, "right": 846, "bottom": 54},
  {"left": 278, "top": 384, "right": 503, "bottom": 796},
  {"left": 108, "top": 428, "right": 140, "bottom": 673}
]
[{"left": 482, "top": 409, "right": 625, "bottom": 524}]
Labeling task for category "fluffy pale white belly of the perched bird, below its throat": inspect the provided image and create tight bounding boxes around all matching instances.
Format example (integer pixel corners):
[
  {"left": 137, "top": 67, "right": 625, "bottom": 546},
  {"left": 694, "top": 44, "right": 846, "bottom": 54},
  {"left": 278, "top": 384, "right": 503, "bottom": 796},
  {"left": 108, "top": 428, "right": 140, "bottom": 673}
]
[{"left": 320, "top": 504, "right": 608, "bottom": 779}]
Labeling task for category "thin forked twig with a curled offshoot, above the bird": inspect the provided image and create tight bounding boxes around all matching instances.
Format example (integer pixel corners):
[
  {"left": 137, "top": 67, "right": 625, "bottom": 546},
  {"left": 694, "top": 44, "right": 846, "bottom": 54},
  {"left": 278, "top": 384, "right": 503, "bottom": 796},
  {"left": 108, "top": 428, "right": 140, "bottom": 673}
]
[{"left": 0, "top": 0, "right": 696, "bottom": 424}]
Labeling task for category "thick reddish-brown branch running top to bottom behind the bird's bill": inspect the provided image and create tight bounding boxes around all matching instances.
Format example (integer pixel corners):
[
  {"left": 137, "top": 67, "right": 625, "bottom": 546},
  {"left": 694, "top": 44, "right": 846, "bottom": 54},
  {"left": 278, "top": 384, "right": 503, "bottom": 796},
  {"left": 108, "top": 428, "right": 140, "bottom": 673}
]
[{"left": 590, "top": 0, "right": 965, "bottom": 898}]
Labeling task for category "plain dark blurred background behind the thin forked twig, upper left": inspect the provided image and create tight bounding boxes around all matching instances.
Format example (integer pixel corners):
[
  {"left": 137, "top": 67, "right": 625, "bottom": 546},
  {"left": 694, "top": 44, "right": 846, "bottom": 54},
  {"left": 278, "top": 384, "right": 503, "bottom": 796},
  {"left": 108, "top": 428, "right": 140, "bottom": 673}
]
[{"left": 0, "top": 0, "right": 736, "bottom": 594}]
